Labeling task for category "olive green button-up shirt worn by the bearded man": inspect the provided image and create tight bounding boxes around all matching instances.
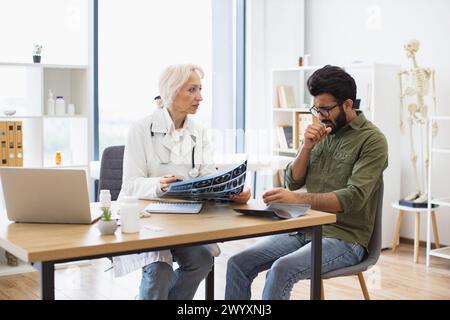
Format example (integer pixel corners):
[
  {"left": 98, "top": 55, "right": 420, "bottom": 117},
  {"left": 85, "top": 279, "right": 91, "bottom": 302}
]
[{"left": 286, "top": 113, "right": 388, "bottom": 250}]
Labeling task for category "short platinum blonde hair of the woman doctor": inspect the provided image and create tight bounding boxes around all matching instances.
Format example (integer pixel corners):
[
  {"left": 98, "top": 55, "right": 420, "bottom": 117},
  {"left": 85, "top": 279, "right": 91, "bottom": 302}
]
[{"left": 159, "top": 63, "right": 204, "bottom": 108}]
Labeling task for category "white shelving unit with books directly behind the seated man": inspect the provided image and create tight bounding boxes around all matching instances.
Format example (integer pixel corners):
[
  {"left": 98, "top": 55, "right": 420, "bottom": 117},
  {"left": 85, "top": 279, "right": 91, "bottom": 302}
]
[{"left": 268, "top": 64, "right": 400, "bottom": 248}]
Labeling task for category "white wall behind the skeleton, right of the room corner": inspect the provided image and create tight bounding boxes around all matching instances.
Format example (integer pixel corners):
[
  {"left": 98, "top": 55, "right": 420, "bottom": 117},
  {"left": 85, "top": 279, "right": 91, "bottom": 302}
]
[{"left": 305, "top": 0, "right": 450, "bottom": 245}]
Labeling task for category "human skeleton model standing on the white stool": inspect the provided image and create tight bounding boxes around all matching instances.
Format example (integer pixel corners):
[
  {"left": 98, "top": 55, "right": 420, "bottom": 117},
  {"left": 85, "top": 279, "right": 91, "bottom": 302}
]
[{"left": 399, "top": 40, "right": 437, "bottom": 203}]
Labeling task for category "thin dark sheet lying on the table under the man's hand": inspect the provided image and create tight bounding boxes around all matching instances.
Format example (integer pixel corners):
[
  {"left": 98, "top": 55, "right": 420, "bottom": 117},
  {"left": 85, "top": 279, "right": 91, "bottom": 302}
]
[{"left": 234, "top": 203, "right": 311, "bottom": 219}]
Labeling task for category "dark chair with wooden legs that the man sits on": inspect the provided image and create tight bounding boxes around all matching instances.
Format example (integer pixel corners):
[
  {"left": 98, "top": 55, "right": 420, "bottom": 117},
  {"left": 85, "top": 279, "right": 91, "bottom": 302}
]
[{"left": 321, "top": 180, "right": 384, "bottom": 300}]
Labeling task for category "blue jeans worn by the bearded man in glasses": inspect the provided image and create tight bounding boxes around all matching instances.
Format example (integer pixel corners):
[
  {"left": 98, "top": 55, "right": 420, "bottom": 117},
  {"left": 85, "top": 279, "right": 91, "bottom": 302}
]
[{"left": 225, "top": 232, "right": 365, "bottom": 300}]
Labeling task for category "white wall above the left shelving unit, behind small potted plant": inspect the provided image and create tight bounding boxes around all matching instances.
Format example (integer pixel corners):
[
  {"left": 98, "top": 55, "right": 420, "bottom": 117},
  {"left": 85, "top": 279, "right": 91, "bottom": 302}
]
[{"left": 0, "top": 0, "right": 89, "bottom": 65}]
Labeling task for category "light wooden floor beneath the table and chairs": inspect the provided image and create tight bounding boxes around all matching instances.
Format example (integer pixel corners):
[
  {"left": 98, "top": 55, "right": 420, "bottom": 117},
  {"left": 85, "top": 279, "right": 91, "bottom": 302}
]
[{"left": 0, "top": 239, "right": 450, "bottom": 300}]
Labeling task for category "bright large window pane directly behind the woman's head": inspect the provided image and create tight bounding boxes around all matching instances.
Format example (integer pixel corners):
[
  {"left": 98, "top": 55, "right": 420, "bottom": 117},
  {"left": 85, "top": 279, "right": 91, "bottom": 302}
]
[{"left": 98, "top": 0, "right": 212, "bottom": 155}]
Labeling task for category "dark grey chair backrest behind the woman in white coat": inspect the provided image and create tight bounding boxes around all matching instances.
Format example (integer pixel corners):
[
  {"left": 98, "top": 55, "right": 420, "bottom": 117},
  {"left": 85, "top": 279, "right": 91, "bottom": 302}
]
[{"left": 98, "top": 146, "right": 125, "bottom": 201}]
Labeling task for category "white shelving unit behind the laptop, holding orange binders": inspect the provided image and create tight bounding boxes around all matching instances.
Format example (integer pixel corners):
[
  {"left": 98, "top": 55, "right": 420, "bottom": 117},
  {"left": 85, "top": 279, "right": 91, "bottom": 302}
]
[{"left": 0, "top": 62, "right": 92, "bottom": 276}]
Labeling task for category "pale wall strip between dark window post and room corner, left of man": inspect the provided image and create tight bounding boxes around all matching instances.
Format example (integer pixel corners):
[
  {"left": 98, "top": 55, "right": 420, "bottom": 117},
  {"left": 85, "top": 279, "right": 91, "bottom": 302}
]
[{"left": 246, "top": 0, "right": 304, "bottom": 195}]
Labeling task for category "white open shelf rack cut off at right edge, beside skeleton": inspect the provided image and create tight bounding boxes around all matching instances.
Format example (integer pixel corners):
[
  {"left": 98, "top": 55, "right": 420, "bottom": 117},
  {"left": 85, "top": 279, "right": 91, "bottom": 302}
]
[{"left": 426, "top": 116, "right": 450, "bottom": 267}]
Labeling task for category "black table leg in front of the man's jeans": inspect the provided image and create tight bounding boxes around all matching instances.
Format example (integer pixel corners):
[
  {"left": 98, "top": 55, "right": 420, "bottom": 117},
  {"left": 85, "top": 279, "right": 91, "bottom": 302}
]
[{"left": 310, "top": 225, "right": 322, "bottom": 300}]
